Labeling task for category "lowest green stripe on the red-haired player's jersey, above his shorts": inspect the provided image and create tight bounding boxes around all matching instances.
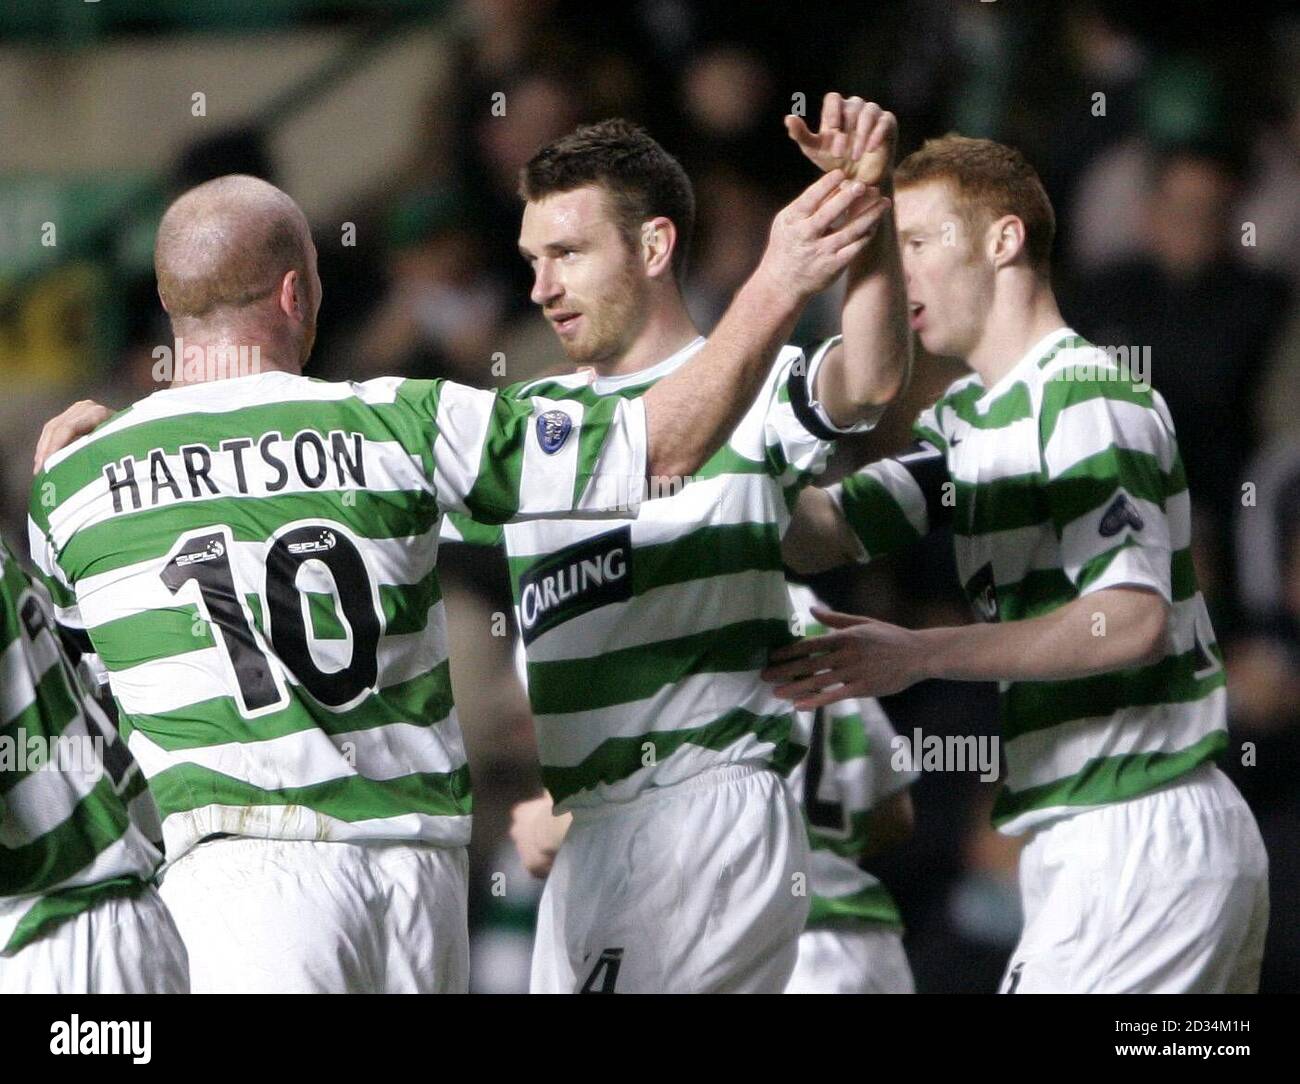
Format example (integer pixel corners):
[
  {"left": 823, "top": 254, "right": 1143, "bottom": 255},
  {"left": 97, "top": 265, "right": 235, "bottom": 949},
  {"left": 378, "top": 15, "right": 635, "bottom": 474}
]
[{"left": 993, "top": 730, "right": 1227, "bottom": 825}]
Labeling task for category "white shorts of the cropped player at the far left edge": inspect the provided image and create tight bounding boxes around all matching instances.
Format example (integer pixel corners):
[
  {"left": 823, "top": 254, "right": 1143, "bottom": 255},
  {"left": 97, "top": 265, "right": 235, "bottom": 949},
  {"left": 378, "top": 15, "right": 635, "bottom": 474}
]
[{"left": 0, "top": 885, "right": 190, "bottom": 994}]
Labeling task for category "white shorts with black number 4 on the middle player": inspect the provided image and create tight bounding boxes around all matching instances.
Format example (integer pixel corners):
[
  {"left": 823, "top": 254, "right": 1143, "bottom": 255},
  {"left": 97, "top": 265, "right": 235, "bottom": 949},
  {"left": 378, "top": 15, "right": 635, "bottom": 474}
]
[{"left": 530, "top": 764, "right": 809, "bottom": 993}]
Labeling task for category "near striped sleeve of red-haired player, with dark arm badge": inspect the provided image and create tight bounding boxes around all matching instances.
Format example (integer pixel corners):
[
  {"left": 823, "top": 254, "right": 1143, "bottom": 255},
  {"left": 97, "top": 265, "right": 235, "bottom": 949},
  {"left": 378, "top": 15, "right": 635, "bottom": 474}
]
[{"left": 1039, "top": 370, "right": 1186, "bottom": 602}]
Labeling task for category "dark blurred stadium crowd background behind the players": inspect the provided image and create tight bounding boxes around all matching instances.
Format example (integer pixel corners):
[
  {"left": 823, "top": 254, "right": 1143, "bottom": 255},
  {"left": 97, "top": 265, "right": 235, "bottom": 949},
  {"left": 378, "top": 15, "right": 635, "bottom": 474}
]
[{"left": 0, "top": 0, "right": 1300, "bottom": 992}]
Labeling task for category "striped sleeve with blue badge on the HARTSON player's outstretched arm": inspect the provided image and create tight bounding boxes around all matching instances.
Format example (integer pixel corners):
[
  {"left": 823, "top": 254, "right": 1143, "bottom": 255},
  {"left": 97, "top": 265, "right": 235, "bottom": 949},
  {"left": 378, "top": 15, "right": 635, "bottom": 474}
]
[{"left": 423, "top": 381, "right": 646, "bottom": 525}]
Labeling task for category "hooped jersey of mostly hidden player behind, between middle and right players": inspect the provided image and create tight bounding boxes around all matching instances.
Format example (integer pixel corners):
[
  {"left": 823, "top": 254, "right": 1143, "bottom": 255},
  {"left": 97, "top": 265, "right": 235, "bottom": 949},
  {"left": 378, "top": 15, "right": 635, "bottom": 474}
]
[{"left": 789, "top": 584, "right": 917, "bottom": 928}]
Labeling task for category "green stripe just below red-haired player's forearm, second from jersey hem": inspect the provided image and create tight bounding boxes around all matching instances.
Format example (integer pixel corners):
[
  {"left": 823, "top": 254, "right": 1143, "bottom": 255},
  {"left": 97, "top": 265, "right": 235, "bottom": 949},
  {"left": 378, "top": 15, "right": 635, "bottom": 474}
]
[{"left": 1001, "top": 643, "right": 1225, "bottom": 741}]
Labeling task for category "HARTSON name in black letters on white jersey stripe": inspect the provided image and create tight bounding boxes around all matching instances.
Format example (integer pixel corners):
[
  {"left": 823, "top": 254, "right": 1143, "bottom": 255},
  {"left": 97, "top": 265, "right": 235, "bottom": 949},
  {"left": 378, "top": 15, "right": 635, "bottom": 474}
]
[{"left": 103, "top": 429, "right": 365, "bottom": 512}]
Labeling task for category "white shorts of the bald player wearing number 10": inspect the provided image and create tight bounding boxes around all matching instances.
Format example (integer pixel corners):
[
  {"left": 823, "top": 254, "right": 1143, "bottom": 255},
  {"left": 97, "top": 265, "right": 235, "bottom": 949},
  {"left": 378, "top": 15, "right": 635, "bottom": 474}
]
[{"left": 163, "top": 838, "right": 469, "bottom": 993}]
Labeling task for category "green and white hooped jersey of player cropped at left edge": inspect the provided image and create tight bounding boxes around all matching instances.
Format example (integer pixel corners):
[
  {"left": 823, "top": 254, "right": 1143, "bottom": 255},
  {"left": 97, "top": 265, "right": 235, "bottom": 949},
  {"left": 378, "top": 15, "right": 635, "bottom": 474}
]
[{"left": 0, "top": 543, "right": 163, "bottom": 951}]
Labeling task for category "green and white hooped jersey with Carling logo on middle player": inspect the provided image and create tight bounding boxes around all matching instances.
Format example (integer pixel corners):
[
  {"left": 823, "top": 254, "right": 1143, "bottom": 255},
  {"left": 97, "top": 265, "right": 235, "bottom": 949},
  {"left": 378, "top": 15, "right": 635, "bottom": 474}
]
[{"left": 445, "top": 338, "right": 867, "bottom": 810}]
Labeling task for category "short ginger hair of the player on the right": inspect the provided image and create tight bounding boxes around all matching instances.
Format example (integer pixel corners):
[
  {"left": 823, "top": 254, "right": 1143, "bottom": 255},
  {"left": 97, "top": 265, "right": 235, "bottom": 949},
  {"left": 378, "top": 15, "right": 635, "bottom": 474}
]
[{"left": 894, "top": 133, "right": 1056, "bottom": 274}]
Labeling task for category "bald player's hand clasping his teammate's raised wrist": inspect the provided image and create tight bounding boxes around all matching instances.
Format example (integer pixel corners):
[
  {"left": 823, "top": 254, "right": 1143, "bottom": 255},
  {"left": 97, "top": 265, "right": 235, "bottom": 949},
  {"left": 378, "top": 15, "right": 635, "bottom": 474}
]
[{"left": 759, "top": 169, "right": 889, "bottom": 299}]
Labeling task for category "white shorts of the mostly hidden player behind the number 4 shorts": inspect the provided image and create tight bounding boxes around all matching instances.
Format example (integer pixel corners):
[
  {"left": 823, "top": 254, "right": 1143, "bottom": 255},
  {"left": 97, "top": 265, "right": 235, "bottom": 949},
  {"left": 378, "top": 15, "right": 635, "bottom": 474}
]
[{"left": 785, "top": 923, "right": 917, "bottom": 993}]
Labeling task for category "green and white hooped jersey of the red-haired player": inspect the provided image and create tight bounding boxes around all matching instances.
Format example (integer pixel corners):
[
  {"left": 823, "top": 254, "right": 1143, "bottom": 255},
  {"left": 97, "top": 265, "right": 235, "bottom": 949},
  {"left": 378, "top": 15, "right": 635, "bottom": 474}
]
[{"left": 831, "top": 328, "right": 1227, "bottom": 833}]
